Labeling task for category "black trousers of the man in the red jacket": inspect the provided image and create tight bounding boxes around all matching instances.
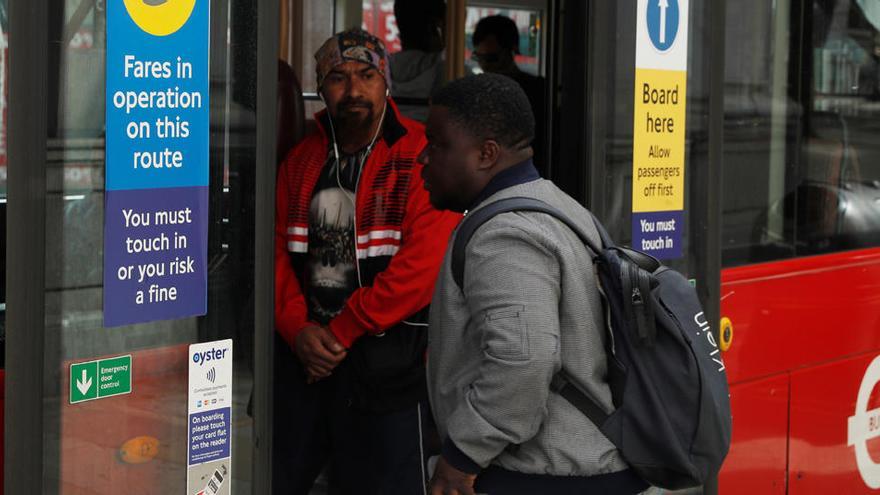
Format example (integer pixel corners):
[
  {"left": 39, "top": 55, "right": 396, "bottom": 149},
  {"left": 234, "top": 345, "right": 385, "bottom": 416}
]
[{"left": 272, "top": 341, "right": 439, "bottom": 495}]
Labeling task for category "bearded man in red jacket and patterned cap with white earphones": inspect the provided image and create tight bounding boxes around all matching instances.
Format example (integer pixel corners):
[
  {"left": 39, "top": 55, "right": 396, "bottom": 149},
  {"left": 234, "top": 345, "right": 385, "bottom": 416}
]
[{"left": 273, "top": 29, "right": 459, "bottom": 495}]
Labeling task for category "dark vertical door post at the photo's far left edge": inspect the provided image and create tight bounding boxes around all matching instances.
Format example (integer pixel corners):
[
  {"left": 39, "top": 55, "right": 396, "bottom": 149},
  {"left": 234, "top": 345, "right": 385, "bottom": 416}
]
[{"left": 4, "top": 1, "right": 48, "bottom": 493}]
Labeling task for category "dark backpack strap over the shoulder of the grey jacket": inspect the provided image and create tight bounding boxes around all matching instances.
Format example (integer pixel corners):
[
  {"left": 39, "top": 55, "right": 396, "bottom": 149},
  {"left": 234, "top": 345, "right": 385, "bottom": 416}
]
[{"left": 452, "top": 196, "right": 614, "bottom": 290}]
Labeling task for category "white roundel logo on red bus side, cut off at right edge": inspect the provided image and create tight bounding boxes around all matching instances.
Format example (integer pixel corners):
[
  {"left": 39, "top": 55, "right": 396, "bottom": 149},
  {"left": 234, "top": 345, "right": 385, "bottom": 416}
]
[{"left": 846, "top": 356, "right": 880, "bottom": 489}]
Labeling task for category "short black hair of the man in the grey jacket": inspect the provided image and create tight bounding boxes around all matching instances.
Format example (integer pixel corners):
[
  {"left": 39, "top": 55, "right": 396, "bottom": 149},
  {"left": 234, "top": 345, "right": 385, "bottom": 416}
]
[{"left": 431, "top": 73, "right": 535, "bottom": 149}]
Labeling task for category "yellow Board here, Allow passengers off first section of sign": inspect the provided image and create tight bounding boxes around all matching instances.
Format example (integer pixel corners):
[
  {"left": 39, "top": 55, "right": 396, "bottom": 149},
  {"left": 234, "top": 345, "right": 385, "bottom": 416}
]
[{"left": 633, "top": 69, "right": 687, "bottom": 212}]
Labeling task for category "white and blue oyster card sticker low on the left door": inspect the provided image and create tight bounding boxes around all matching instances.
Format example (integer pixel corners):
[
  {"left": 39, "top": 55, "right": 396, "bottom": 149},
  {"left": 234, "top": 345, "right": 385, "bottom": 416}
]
[{"left": 186, "top": 339, "right": 232, "bottom": 495}]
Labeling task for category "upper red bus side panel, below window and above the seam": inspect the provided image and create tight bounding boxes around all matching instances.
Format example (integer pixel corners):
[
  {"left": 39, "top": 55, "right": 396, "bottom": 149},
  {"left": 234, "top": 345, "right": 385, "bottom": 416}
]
[{"left": 721, "top": 248, "right": 880, "bottom": 384}]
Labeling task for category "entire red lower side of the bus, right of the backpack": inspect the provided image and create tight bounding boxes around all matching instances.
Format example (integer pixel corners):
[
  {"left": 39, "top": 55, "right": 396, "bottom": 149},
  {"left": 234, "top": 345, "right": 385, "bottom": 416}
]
[{"left": 719, "top": 248, "right": 880, "bottom": 495}]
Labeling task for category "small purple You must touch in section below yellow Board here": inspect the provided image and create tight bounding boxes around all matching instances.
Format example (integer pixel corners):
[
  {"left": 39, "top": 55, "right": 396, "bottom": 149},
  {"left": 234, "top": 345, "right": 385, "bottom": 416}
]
[{"left": 632, "top": 211, "right": 684, "bottom": 260}]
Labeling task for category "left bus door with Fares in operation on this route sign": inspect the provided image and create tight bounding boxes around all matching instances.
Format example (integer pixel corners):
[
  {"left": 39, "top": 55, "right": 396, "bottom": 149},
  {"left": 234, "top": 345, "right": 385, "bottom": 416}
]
[{"left": 0, "top": 0, "right": 278, "bottom": 495}]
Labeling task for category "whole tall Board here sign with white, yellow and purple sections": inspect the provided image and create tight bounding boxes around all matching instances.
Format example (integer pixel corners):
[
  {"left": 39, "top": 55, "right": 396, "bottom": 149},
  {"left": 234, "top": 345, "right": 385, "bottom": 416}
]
[{"left": 632, "top": 0, "right": 690, "bottom": 259}]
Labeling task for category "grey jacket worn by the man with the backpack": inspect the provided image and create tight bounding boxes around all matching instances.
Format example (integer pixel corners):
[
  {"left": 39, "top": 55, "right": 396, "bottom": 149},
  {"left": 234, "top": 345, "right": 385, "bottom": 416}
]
[{"left": 428, "top": 179, "right": 627, "bottom": 476}]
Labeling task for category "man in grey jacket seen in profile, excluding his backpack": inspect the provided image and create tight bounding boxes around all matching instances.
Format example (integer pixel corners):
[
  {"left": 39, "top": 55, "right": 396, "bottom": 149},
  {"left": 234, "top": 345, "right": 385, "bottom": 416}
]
[{"left": 419, "top": 74, "right": 647, "bottom": 495}]
